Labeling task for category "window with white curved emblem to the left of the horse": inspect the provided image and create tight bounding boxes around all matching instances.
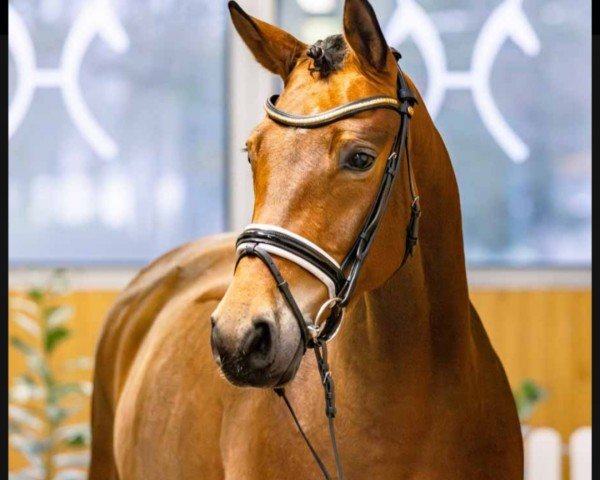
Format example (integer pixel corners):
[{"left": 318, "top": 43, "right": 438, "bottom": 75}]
[{"left": 9, "top": 0, "right": 229, "bottom": 265}]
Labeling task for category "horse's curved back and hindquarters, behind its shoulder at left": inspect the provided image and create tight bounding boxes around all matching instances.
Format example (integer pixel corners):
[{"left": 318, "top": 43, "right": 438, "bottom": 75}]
[{"left": 90, "top": 233, "right": 235, "bottom": 480}]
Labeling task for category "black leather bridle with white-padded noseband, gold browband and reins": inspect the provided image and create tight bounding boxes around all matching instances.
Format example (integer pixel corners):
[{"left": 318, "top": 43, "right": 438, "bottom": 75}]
[{"left": 236, "top": 49, "right": 421, "bottom": 480}]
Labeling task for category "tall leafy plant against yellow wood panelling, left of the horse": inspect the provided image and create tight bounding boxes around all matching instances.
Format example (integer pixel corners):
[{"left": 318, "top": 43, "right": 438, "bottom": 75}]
[{"left": 9, "top": 270, "right": 92, "bottom": 480}]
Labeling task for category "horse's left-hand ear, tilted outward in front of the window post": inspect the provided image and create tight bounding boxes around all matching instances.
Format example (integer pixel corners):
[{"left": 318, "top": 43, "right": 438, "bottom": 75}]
[{"left": 228, "top": 1, "right": 307, "bottom": 81}]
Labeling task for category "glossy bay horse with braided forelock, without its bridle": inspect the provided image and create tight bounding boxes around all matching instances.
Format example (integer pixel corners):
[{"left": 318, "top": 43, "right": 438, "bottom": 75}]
[{"left": 89, "top": 0, "right": 523, "bottom": 480}]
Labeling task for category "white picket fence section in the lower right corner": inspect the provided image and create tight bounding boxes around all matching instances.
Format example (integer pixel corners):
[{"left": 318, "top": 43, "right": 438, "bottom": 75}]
[{"left": 524, "top": 427, "right": 592, "bottom": 480}]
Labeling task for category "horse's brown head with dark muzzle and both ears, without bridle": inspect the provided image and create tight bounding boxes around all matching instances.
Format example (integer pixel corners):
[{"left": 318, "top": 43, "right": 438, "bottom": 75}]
[{"left": 211, "top": 0, "right": 420, "bottom": 387}]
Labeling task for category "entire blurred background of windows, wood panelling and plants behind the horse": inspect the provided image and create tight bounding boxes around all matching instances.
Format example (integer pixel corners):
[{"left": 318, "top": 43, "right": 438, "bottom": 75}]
[{"left": 9, "top": 0, "right": 591, "bottom": 480}]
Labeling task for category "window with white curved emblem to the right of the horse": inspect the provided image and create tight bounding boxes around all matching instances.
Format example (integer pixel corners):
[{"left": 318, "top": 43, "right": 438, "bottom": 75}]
[{"left": 278, "top": 0, "right": 591, "bottom": 267}]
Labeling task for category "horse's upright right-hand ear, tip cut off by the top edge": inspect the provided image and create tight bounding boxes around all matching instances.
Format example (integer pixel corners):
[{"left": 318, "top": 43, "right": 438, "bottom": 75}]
[{"left": 344, "top": 0, "right": 390, "bottom": 72}]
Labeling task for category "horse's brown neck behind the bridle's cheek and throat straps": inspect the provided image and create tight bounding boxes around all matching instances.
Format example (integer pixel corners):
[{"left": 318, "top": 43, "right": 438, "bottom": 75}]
[{"left": 335, "top": 104, "right": 471, "bottom": 398}]
